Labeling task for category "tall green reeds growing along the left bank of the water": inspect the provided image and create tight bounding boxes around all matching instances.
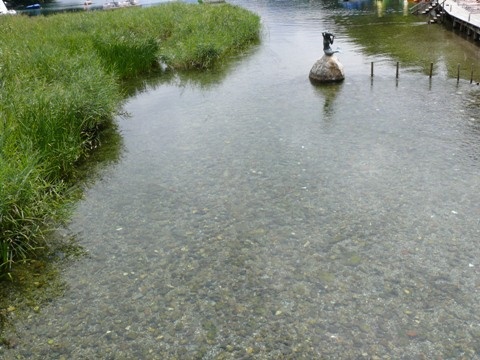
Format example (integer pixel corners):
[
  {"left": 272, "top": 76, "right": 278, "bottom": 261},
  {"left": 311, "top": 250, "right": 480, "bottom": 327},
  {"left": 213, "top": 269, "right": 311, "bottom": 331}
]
[{"left": 0, "top": 3, "right": 260, "bottom": 276}]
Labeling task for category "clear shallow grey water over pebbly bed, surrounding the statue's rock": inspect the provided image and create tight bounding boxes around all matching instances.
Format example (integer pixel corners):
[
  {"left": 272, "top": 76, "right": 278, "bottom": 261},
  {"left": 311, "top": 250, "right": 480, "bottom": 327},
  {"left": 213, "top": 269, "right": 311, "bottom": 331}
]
[{"left": 0, "top": 1, "right": 480, "bottom": 359}]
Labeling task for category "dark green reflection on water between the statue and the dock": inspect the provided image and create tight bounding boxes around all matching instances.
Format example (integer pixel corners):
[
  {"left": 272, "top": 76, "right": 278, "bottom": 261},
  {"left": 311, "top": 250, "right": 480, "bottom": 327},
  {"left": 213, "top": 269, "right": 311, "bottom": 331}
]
[{"left": 337, "top": 2, "right": 479, "bottom": 79}]
